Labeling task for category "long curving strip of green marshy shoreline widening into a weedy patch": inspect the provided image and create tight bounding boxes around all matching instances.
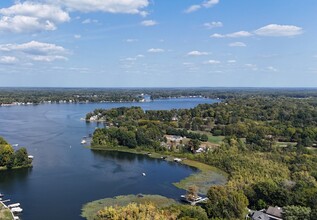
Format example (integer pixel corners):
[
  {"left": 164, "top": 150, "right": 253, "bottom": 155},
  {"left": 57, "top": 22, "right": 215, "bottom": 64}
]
[{"left": 87, "top": 146, "right": 228, "bottom": 195}]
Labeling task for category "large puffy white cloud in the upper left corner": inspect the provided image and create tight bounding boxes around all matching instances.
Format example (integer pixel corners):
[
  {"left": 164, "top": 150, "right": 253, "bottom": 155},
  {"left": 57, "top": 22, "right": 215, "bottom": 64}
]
[{"left": 0, "top": 1, "right": 70, "bottom": 33}]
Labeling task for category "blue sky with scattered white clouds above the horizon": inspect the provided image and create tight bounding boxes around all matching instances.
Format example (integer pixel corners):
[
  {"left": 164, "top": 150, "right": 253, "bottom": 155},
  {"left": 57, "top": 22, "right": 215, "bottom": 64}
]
[{"left": 0, "top": 0, "right": 317, "bottom": 87}]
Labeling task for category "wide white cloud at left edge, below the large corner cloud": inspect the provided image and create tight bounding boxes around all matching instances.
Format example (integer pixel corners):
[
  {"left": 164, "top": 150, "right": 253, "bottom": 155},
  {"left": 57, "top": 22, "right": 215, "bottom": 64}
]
[{"left": 0, "top": 41, "right": 68, "bottom": 62}]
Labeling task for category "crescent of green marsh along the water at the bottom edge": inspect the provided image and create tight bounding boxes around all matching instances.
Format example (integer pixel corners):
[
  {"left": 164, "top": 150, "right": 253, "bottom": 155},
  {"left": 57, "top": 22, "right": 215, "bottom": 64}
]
[{"left": 81, "top": 195, "right": 176, "bottom": 220}]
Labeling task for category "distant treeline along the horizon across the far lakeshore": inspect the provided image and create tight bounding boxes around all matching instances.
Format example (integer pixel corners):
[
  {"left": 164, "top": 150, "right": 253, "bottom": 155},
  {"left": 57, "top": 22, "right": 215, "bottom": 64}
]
[{"left": 0, "top": 88, "right": 317, "bottom": 105}]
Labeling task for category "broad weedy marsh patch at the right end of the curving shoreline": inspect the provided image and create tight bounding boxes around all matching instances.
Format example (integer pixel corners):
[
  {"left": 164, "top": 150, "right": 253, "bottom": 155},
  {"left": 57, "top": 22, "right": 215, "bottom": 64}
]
[{"left": 174, "top": 160, "right": 227, "bottom": 195}]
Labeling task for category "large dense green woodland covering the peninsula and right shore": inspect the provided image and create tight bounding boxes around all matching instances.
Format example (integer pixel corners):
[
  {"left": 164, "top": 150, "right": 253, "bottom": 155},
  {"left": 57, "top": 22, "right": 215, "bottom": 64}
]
[{"left": 86, "top": 93, "right": 317, "bottom": 219}]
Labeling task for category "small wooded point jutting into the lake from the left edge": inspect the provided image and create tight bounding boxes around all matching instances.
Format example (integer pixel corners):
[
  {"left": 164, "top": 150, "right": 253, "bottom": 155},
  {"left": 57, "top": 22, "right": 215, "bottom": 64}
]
[{"left": 0, "top": 137, "right": 32, "bottom": 170}]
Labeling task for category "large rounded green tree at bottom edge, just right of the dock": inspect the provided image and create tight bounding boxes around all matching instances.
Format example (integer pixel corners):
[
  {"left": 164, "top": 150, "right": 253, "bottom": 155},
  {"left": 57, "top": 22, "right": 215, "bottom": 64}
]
[{"left": 206, "top": 186, "right": 249, "bottom": 219}]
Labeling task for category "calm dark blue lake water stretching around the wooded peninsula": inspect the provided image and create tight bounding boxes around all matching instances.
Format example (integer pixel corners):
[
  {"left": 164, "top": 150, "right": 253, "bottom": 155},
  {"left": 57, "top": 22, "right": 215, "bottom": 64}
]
[{"left": 0, "top": 98, "right": 215, "bottom": 220}]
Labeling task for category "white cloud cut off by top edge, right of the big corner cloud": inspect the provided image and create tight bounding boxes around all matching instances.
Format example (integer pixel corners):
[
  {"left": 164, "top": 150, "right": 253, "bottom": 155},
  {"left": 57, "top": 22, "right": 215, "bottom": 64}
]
[{"left": 50, "top": 0, "right": 149, "bottom": 16}]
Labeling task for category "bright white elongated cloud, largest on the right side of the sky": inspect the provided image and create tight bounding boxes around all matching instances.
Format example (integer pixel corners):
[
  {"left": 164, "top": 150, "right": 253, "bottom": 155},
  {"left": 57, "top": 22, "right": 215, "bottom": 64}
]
[{"left": 254, "top": 24, "right": 303, "bottom": 37}]
